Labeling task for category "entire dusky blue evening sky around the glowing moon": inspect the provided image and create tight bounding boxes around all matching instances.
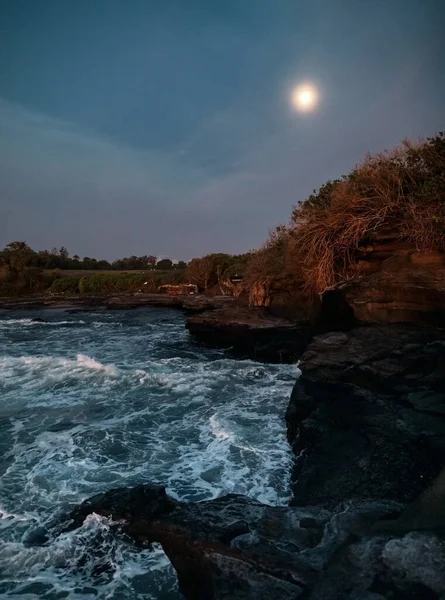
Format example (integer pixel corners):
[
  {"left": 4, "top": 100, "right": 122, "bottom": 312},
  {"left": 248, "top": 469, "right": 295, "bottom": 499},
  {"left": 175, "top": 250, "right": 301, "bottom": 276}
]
[{"left": 0, "top": 0, "right": 445, "bottom": 259}]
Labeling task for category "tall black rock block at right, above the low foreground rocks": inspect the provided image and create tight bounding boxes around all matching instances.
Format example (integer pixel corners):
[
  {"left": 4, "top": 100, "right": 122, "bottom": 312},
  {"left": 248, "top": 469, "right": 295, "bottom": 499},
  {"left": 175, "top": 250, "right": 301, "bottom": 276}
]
[{"left": 286, "top": 325, "right": 445, "bottom": 506}]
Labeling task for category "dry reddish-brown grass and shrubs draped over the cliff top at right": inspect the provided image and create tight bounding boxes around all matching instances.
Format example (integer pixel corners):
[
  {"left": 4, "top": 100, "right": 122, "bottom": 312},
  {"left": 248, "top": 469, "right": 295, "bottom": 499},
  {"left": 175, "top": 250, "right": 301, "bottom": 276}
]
[{"left": 248, "top": 134, "right": 445, "bottom": 294}]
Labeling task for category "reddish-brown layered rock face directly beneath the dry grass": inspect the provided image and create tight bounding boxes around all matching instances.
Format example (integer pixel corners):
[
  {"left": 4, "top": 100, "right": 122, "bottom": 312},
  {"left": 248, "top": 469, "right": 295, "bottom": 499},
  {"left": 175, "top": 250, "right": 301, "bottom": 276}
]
[{"left": 243, "top": 232, "right": 445, "bottom": 327}]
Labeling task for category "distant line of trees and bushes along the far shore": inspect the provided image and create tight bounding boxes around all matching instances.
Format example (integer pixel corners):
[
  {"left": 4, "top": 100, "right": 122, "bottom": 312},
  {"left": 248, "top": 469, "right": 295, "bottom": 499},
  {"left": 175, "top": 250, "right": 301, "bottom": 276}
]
[{"left": 0, "top": 242, "right": 253, "bottom": 296}]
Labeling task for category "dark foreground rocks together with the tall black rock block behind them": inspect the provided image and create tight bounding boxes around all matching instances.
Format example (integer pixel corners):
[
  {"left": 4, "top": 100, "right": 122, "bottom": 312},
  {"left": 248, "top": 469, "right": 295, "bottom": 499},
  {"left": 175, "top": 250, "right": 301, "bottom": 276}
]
[{"left": 49, "top": 324, "right": 445, "bottom": 600}]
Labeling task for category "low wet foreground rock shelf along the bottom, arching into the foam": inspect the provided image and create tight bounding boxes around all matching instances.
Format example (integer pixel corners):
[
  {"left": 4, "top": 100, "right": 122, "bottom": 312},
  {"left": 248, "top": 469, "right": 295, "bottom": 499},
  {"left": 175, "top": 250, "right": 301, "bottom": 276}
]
[{"left": 56, "top": 485, "right": 445, "bottom": 600}]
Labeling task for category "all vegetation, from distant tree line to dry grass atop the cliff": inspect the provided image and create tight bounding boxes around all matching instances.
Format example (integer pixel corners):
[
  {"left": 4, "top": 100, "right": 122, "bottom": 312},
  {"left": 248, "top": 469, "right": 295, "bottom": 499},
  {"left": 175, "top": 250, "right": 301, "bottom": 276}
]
[{"left": 0, "top": 133, "right": 445, "bottom": 305}]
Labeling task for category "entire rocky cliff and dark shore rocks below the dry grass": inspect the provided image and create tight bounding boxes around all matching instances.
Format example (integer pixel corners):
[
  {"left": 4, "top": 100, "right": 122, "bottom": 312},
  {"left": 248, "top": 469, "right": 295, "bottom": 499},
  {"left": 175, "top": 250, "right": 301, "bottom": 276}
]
[{"left": 32, "top": 236, "right": 445, "bottom": 600}]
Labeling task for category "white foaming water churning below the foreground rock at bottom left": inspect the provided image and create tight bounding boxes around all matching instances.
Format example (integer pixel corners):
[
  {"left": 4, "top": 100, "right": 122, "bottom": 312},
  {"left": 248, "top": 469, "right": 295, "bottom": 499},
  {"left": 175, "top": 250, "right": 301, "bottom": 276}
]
[{"left": 0, "top": 513, "right": 180, "bottom": 600}]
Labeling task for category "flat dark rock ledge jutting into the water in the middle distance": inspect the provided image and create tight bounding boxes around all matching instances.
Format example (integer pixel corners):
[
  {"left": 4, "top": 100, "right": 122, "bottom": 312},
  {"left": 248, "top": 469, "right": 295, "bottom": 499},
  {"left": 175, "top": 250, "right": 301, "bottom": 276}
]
[{"left": 186, "top": 306, "right": 313, "bottom": 362}]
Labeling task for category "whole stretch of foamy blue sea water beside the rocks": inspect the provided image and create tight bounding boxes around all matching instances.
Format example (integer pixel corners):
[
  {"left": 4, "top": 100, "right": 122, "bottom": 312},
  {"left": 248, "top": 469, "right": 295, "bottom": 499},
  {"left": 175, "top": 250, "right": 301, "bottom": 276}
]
[{"left": 0, "top": 308, "right": 298, "bottom": 600}]
